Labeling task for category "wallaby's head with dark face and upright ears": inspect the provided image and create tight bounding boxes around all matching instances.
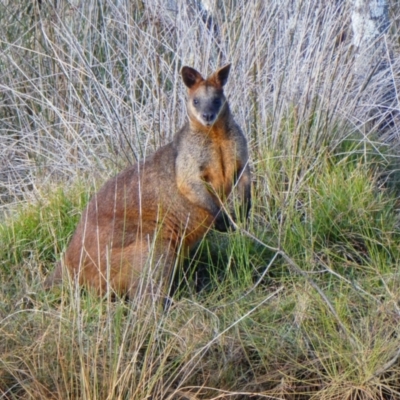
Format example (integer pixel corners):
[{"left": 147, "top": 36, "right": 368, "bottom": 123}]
[{"left": 182, "top": 64, "right": 231, "bottom": 127}]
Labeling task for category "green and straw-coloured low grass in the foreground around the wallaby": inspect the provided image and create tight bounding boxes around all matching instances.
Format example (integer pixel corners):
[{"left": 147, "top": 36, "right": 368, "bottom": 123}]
[{"left": 0, "top": 137, "right": 400, "bottom": 399}]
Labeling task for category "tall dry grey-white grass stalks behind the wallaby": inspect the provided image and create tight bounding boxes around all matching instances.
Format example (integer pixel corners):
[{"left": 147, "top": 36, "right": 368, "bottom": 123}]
[{"left": 0, "top": 0, "right": 397, "bottom": 201}]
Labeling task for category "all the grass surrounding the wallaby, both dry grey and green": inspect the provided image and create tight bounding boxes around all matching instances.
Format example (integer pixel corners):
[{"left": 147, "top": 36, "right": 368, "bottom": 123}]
[{"left": 0, "top": 0, "right": 400, "bottom": 399}]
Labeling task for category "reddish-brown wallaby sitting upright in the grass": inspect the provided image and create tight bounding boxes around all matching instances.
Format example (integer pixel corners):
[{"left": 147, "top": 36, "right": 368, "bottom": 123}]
[{"left": 45, "top": 65, "right": 250, "bottom": 295}]
